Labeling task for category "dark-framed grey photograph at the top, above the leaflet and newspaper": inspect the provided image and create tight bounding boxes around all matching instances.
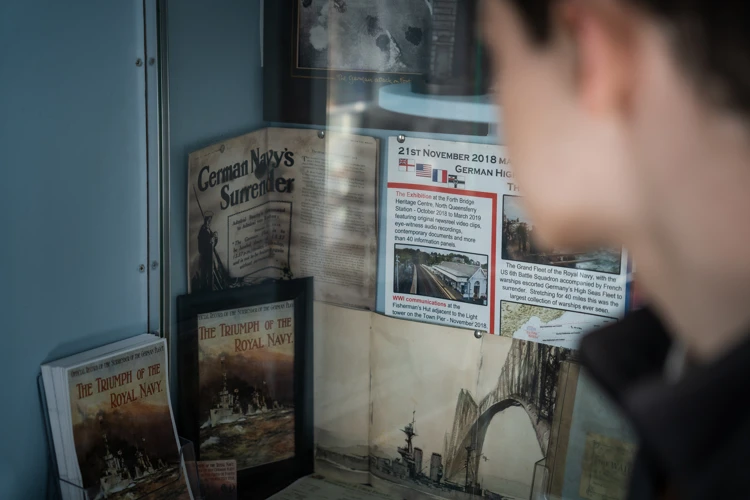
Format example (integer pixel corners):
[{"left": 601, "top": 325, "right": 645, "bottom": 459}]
[{"left": 263, "top": 0, "right": 489, "bottom": 136}]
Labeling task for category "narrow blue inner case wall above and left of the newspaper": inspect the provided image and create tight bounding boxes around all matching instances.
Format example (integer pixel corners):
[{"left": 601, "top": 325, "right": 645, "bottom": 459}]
[{"left": 167, "top": 0, "right": 263, "bottom": 336}]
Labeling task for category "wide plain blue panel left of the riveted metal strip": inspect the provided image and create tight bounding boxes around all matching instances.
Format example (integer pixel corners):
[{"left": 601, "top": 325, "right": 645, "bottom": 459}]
[{"left": 0, "top": 0, "right": 147, "bottom": 499}]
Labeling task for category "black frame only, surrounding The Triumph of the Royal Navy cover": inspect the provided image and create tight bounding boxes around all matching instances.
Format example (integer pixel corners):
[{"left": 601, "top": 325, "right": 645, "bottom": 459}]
[{"left": 176, "top": 278, "right": 314, "bottom": 498}]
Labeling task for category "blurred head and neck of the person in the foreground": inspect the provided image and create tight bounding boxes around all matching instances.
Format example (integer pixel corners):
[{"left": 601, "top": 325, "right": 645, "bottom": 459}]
[{"left": 481, "top": 0, "right": 750, "bottom": 360}]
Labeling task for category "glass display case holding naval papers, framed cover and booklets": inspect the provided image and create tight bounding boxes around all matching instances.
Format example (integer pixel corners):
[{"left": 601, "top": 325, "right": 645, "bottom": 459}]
[{"left": 23, "top": 0, "right": 635, "bottom": 500}]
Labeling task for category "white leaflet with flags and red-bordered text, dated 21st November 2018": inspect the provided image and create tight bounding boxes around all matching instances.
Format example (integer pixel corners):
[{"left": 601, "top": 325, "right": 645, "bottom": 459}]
[{"left": 385, "top": 138, "right": 627, "bottom": 348}]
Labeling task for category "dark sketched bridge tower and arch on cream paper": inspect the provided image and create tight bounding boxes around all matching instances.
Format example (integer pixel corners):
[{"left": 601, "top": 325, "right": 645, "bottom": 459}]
[{"left": 444, "top": 340, "right": 567, "bottom": 483}]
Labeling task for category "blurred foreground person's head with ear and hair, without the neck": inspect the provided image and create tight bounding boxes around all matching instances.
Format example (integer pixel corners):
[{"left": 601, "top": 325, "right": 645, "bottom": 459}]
[{"left": 482, "top": 0, "right": 750, "bottom": 249}]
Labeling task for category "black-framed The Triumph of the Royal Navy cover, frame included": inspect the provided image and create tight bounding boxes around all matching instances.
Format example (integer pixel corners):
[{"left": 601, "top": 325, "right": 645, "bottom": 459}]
[{"left": 177, "top": 278, "right": 314, "bottom": 498}]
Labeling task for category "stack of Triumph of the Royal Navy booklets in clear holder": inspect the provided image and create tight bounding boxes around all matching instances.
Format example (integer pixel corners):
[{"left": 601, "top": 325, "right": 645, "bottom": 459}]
[{"left": 42, "top": 334, "right": 192, "bottom": 500}]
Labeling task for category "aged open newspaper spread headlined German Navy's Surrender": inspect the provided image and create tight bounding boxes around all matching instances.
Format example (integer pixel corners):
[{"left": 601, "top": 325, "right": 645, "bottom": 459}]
[{"left": 187, "top": 128, "right": 378, "bottom": 310}]
